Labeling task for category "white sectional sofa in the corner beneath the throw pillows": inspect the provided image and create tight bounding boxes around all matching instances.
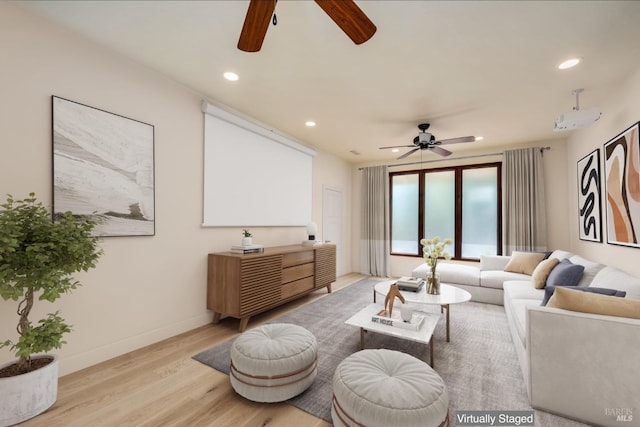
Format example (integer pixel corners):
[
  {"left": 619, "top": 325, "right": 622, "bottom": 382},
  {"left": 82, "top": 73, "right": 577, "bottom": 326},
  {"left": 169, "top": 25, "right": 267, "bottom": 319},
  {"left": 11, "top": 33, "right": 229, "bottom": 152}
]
[{"left": 413, "top": 250, "right": 640, "bottom": 426}]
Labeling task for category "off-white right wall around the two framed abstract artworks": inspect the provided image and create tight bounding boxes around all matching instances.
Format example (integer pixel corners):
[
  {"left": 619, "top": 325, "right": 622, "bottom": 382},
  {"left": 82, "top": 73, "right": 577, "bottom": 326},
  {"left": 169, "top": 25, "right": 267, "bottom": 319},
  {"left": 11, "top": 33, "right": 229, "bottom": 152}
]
[{"left": 566, "top": 67, "right": 640, "bottom": 276}]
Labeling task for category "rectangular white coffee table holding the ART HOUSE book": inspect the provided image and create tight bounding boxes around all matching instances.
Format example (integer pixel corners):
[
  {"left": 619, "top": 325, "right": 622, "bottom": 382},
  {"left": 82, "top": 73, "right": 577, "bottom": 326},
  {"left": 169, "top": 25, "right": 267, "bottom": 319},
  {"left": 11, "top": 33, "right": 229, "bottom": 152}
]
[{"left": 344, "top": 303, "right": 440, "bottom": 368}]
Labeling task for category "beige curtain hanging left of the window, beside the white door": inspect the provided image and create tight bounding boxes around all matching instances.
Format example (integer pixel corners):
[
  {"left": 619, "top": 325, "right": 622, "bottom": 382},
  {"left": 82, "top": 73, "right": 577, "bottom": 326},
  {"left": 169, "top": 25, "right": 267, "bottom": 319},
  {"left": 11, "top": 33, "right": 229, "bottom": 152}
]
[{"left": 360, "top": 166, "right": 391, "bottom": 277}]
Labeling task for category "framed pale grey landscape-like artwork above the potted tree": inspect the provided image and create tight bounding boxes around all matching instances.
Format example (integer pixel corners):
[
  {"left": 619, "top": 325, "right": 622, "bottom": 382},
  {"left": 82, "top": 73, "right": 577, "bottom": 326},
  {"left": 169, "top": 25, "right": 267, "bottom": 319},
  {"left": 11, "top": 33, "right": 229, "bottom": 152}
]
[{"left": 52, "top": 96, "right": 155, "bottom": 237}]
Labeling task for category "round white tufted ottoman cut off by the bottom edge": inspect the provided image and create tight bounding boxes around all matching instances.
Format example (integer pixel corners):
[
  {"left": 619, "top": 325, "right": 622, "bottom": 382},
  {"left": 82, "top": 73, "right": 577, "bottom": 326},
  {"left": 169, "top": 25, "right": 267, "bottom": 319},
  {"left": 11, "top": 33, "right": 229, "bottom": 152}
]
[{"left": 331, "top": 350, "right": 449, "bottom": 427}]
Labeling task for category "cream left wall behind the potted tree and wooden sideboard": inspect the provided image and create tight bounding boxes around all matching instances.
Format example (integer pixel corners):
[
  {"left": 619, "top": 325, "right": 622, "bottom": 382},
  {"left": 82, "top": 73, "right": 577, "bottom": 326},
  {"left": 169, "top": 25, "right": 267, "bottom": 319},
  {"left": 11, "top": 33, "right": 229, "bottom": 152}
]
[{"left": 0, "top": 2, "right": 351, "bottom": 374}]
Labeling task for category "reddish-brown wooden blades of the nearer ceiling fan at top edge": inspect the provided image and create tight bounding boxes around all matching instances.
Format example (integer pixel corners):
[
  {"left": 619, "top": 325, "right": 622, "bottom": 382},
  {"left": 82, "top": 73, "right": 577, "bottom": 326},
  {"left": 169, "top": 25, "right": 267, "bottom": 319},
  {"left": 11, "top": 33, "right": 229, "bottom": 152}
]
[{"left": 238, "top": 0, "right": 377, "bottom": 52}]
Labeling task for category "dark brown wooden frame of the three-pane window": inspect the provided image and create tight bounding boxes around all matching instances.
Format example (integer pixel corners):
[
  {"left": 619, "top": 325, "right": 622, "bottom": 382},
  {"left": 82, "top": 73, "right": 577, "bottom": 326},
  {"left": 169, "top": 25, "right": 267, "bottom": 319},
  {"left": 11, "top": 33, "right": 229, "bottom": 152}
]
[{"left": 389, "top": 162, "right": 502, "bottom": 261}]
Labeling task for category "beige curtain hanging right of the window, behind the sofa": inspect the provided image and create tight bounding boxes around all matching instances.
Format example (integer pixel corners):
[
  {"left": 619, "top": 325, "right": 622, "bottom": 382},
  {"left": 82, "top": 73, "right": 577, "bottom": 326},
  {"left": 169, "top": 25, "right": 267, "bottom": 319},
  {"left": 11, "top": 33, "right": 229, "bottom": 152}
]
[{"left": 502, "top": 147, "right": 547, "bottom": 255}]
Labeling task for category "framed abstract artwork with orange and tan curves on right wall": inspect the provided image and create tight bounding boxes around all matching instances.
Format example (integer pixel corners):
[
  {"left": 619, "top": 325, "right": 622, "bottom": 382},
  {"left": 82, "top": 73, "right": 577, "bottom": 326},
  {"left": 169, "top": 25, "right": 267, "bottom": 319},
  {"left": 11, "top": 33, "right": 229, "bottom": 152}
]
[{"left": 603, "top": 123, "right": 640, "bottom": 248}]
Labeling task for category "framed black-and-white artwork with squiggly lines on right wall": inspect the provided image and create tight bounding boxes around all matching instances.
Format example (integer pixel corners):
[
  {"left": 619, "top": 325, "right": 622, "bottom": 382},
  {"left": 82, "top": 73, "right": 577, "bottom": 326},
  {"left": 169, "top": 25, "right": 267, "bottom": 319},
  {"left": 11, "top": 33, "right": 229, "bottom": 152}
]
[{"left": 578, "top": 149, "right": 602, "bottom": 242}]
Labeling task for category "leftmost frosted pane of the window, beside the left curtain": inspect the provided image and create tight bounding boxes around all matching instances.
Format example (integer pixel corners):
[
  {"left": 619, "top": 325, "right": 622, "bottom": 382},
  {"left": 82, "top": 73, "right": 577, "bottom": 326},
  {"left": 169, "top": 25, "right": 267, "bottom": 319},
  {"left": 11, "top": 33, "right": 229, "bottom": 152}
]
[{"left": 391, "top": 174, "right": 418, "bottom": 255}]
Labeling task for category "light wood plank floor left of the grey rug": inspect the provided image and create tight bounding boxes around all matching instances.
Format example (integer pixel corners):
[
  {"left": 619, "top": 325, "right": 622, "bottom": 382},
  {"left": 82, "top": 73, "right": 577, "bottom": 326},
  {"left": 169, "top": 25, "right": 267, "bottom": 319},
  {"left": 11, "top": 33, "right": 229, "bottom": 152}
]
[{"left": 21, "top": 273, "right": 365, "bottom": 427}]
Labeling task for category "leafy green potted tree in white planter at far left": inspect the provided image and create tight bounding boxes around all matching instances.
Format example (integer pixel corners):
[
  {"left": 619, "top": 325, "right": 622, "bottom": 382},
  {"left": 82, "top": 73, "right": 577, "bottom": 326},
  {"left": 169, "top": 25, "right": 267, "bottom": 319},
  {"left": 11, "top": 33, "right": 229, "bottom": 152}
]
[{"left": 0, "top": 193, "right": 102, "bottom": 426}]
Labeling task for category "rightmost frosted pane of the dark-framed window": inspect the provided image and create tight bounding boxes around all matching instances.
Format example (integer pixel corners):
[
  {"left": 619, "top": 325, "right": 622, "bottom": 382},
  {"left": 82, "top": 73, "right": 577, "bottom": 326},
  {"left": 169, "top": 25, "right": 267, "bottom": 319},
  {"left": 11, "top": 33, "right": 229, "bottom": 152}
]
[{"left": 462, "top": 167, "right": 498, "bottom": 258}]
